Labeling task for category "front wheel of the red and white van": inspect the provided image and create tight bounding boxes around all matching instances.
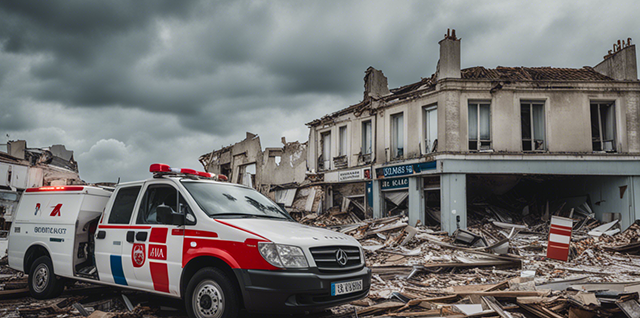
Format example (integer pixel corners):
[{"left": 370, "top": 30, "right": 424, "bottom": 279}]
[{"left": 184, "top": 268, "right": 239, "bottom": 318}]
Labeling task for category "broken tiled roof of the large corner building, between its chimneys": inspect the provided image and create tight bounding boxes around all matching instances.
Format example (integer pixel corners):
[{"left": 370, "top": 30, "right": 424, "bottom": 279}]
[{"left": 307, "top": 66, "right": 615, "bottom": 126}]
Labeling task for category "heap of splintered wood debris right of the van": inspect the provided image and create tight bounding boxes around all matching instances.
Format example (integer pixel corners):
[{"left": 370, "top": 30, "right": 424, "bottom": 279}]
[{"left": 300, "top": 203, "right": 640, "bottom": 318}]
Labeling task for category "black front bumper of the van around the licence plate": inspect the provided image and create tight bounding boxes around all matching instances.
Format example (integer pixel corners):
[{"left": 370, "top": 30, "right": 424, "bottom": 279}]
[{"left": 234, "top": 267, "right": 371, "bottom": 313}]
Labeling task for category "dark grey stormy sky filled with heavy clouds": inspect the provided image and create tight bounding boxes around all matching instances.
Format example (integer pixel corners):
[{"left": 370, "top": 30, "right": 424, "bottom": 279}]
[{"left": 0, "top": 0, "right": 640, "bottom": 182}]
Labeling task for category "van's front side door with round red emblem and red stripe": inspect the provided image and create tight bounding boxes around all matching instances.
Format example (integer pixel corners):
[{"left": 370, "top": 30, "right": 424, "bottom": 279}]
[{"left": 123, "top": 182, "right": 186, "bottom": 296}]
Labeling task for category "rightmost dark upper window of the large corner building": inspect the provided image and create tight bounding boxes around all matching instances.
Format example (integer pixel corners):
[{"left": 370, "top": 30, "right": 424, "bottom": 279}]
[{"left": 591, "top": 102, "right": 616, "bottom": 152}]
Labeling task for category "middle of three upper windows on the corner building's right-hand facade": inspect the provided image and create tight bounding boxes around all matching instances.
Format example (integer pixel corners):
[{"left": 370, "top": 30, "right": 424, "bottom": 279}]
[{"left": 520, "top": 102, "right": 546, "bottom": 151}]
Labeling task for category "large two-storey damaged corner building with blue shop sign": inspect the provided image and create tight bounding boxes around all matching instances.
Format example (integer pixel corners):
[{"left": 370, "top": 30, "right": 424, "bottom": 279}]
[{"left": 307, "top": 31, "right": 640, "bottom": 233}]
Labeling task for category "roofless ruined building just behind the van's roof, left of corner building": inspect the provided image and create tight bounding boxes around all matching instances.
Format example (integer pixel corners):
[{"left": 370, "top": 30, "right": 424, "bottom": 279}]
[{"left": 199, "top": 132, "right": 322, "bottom": 211}]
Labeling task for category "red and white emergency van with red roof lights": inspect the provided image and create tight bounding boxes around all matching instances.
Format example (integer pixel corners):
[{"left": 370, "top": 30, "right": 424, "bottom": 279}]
[{"left": 8, "top": 164, "right": 371, "bottom": 318}]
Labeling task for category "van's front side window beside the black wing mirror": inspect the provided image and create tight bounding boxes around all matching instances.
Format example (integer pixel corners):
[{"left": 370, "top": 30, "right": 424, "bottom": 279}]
[{"left": 136, "top": 185, "right": 178, "bottom": 224}]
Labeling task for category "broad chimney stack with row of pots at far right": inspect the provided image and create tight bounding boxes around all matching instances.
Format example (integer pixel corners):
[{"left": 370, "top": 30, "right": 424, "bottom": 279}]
[{"left": 593, "top": 38, "right": 638, "bottom": 81}]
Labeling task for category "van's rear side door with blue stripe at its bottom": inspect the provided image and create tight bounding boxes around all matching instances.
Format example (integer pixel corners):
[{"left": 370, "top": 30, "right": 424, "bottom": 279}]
[{"left": 95, "top": 186, "right": 141, "bottom": 286}]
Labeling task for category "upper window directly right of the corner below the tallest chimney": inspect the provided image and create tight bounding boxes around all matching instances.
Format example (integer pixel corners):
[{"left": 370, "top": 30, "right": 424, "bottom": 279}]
[{"left": 469, "top": 102, "right": 491, "bottom": 151}]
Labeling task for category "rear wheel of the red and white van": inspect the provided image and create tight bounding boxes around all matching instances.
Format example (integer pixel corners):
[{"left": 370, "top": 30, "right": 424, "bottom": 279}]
[{"left": 29, "top": 256, "right": 64, "bottom": 299}]
